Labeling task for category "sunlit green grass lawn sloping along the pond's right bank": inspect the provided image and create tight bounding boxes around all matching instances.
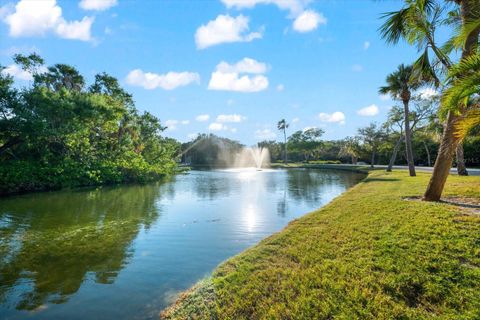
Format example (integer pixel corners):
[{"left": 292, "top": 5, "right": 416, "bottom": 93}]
[{"left": 162, "top": 171, "right": 480, "bottom": 319}]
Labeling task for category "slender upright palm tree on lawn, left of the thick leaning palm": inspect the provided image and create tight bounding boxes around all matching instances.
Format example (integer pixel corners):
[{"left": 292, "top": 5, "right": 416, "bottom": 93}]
[{"left": 379, "top": 64, "right": 420, "bottom": 177}]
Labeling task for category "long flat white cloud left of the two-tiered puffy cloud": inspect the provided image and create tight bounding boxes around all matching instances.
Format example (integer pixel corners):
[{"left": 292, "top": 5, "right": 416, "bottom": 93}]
[{"left": 126, "top": 69, "right": 200, "bottom": 90}]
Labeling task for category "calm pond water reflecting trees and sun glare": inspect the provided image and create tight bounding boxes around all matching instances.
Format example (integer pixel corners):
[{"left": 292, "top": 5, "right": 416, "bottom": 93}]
[{"left": 0, "top": 169, "right": 363, "bottom": 319}]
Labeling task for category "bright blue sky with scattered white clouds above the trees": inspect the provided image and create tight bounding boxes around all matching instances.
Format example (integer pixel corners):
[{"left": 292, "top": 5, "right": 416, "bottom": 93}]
[{"left": 0, "top": 0, "right": 434, "bottom": 145}]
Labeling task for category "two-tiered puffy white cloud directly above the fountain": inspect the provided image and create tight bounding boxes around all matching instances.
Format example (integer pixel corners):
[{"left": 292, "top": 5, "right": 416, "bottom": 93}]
[{"left": 208, "top": 58, "right": 268, "bottom": 92}]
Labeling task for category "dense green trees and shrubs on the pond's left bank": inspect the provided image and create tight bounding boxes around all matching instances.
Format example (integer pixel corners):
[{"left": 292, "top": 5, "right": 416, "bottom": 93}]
[{"left": 0, "top": 54, "right": 178, "bottom": 194}]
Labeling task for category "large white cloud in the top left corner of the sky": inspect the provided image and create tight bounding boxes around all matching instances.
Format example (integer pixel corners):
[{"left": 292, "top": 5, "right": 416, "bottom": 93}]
[{"left": 3, "top": 0, "right": 95, "bottom": 41}]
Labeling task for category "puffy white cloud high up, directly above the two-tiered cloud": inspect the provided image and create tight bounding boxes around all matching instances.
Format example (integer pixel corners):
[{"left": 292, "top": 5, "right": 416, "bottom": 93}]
[{"left": 195, "top": 14, "right": 262, "bottom": 49}]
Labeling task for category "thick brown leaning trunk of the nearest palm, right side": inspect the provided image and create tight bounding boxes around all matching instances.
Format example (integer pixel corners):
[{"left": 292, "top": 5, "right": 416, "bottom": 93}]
[{"left": 423, "top": 0, "right": 480, "bottom": 201}]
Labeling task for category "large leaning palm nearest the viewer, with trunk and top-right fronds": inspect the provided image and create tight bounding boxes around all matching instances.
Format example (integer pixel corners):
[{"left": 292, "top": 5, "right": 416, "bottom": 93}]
[{"left": 380, "top": 0, "right": 480, "bottom": 201}]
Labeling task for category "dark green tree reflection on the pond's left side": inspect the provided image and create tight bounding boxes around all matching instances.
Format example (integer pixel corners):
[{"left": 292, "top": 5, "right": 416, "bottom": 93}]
[{"left": 0, "top": 183, "right": 174, "bottom": 310}]
